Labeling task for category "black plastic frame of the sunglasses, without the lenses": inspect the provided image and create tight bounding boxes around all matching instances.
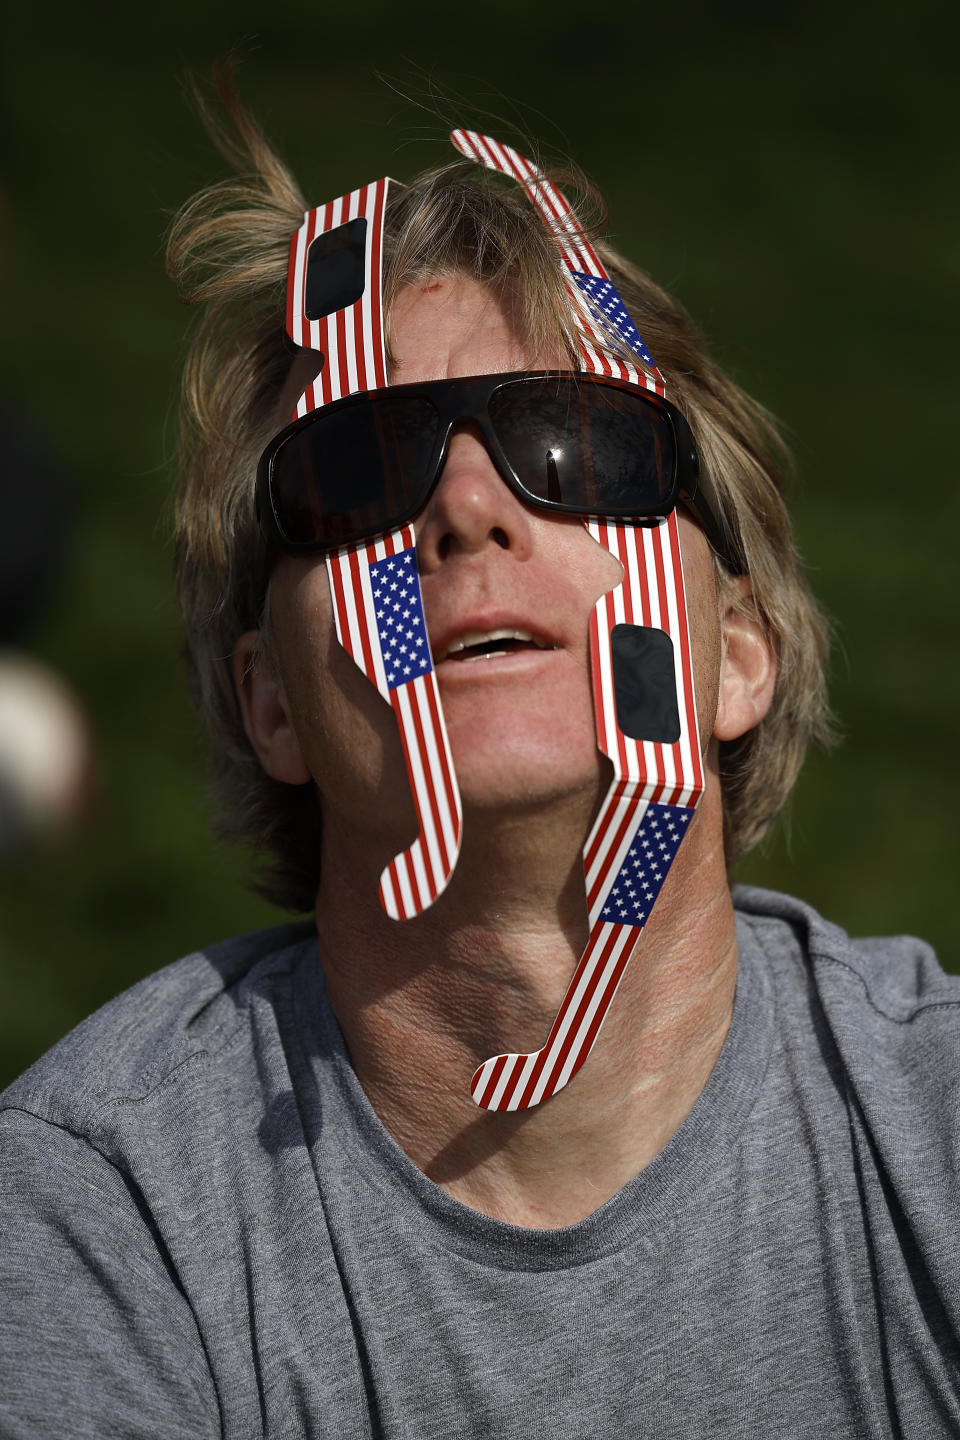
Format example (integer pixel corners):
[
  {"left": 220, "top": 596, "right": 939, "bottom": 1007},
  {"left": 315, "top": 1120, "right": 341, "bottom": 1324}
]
[{"left": 256, "top": 370, "right": 744, "bottom": 575}]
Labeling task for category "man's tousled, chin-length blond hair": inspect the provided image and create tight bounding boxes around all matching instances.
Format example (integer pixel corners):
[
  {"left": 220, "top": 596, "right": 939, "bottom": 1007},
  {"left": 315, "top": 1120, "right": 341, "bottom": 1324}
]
[{"left": 167, "top": 78, "right": 830, "bottom": 910}]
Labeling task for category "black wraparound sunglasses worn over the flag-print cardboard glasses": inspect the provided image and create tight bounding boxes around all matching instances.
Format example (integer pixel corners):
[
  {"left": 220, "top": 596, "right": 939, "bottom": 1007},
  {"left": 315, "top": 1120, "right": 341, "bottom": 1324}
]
[{"left": 256, "top": 370, "right": 743, "bottom": 572}]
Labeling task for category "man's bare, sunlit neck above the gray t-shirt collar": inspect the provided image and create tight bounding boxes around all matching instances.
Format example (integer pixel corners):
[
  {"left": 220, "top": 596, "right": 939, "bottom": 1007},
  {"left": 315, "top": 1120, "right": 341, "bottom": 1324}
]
[{"left": 317, "top": 773, "right": 737, "bottom": 1228}]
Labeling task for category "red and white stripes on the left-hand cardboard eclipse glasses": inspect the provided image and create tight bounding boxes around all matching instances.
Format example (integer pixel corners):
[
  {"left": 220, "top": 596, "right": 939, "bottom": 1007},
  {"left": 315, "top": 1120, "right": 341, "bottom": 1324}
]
[{"left": 286, "top": 179, "right": 462, "bottom": 920}]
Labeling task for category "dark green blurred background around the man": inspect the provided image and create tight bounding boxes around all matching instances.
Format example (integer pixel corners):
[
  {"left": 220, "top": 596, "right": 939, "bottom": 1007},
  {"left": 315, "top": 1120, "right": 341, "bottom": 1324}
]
[{"left": 0, "top": 0, "right": 960, "bottom": 1083}]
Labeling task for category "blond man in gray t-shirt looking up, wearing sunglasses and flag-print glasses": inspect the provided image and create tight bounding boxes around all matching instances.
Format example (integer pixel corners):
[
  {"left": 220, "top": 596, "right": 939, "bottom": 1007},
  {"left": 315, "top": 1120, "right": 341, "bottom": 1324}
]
[{"left": 0, "top": 95, "right": 960, "bottom": 1437}]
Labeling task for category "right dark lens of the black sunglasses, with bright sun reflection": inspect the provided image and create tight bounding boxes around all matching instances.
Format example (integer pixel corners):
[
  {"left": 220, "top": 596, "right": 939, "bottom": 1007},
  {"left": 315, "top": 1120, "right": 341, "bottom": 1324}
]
[{"left": 489, "top": 377, "right": 675, "bottom": 517}]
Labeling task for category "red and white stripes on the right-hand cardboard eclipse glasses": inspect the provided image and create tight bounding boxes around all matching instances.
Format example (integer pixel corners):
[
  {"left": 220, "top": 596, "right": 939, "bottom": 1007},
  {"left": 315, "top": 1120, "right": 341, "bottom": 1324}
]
[{"left": 452, "top": 130, "right": 704, "bottom": 1110}]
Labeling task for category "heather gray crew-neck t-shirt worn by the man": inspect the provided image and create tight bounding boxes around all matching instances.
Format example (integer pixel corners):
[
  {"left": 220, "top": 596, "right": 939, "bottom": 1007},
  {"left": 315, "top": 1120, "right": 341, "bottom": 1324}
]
[{"left": 0, "top": 890, "right": 960, "bottom": 1440}]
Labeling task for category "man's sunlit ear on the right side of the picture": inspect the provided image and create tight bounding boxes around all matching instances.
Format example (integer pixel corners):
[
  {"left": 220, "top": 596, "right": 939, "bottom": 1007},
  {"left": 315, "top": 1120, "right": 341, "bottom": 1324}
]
[{"left": 714, "top": 576, "right": 777, "bottom": 740}]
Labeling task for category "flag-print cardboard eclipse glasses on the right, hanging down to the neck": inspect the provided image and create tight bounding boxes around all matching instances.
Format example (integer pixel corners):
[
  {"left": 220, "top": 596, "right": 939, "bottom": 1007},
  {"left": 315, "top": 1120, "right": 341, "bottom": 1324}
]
[{"left": 452, "top": 130, "right": 704, "bottom": 1110}]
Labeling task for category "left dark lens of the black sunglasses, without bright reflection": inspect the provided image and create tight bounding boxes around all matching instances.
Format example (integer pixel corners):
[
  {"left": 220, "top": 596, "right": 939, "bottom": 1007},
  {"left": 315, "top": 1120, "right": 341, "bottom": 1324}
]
[{"left": 271, "top": 396, "right": 438, "bottom": 547}]
